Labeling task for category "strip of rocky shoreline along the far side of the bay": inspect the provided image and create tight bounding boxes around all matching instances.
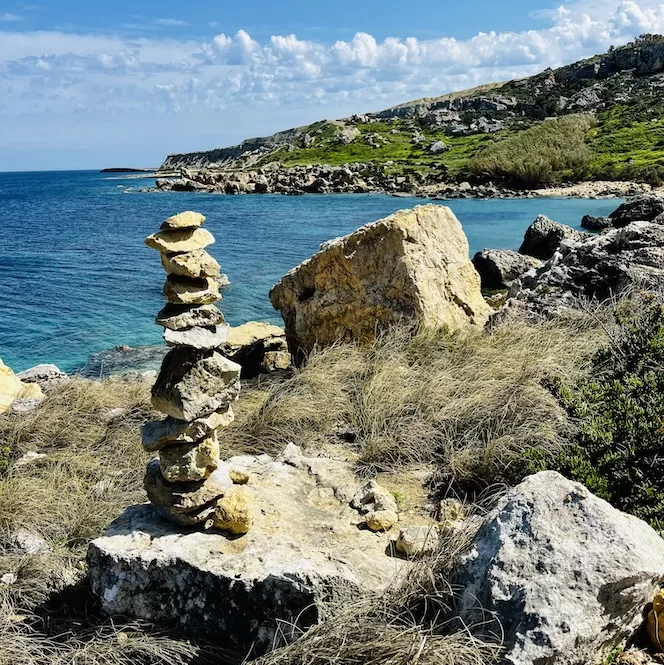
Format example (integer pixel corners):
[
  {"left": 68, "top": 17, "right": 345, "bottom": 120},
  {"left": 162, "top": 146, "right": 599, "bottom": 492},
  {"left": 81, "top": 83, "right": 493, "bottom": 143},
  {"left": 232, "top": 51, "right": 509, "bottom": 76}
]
[{"left": 143, "top": 162, "right": 653, "bottom": 200}]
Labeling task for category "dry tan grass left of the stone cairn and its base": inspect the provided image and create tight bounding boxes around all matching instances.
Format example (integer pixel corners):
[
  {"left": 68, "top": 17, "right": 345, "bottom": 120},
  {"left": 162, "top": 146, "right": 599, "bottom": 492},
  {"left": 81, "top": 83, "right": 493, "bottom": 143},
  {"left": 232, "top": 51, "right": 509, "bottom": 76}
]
[{"left": 0, "top": 380, "right": 233, "bottom": 665}]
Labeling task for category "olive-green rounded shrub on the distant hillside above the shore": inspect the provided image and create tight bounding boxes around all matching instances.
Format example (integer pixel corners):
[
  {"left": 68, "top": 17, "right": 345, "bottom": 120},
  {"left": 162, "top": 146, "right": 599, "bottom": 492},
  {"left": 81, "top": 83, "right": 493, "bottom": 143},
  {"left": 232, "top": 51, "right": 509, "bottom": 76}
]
[{"left": 468, "top": 115, "right": 594, "bottom": 187}]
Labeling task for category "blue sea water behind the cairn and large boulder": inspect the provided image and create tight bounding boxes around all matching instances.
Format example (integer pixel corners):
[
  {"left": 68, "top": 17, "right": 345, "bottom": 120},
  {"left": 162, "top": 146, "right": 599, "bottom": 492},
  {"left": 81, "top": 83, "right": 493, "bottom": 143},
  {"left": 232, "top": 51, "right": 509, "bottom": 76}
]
[{"left": 0, "top": 171, "right": 619, "bottom": 371}]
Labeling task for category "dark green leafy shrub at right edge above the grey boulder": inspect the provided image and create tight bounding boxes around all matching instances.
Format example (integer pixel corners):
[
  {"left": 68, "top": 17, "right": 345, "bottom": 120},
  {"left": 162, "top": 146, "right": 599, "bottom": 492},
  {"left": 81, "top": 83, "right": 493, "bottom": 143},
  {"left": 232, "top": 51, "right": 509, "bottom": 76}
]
[{"left": 554, "top": 296, "right": 664, "bottom": 526}]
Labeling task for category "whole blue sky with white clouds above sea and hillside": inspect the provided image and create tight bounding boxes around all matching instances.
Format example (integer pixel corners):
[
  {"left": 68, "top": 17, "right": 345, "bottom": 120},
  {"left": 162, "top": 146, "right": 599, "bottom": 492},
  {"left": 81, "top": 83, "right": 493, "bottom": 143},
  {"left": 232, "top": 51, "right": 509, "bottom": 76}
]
[{"left": 0, "top": 0, "right": 664, "bottom": 170}]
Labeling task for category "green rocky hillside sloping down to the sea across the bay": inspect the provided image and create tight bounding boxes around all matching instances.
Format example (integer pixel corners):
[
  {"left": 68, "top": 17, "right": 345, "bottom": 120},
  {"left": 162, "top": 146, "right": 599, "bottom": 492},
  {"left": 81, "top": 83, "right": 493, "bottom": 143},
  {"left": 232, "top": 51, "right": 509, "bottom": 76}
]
[{"left": 160, "top": 35, "right": 664, "bottom": 195}]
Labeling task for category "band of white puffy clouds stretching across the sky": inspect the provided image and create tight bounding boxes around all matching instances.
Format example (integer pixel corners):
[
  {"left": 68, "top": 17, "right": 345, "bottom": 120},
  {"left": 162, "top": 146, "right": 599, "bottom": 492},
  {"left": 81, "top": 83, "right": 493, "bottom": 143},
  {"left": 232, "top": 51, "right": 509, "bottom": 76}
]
[{"left": 0, "top": 0, "right": 664, "bottom": 114}]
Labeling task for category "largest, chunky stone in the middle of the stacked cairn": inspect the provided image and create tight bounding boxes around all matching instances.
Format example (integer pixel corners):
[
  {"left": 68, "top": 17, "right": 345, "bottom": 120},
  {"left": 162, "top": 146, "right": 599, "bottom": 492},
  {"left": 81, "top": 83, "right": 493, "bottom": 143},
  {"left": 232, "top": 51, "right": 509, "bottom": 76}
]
[{"left": 152, "top": 347, "right": 241, "bottom": 420}]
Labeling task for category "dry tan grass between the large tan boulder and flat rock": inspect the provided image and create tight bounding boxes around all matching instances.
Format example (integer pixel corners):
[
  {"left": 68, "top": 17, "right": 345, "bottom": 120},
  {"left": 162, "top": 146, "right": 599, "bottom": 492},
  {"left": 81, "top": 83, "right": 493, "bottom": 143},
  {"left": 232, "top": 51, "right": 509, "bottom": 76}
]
[{"left": 218, "top": 316, "right": 603, "bottom": 486}]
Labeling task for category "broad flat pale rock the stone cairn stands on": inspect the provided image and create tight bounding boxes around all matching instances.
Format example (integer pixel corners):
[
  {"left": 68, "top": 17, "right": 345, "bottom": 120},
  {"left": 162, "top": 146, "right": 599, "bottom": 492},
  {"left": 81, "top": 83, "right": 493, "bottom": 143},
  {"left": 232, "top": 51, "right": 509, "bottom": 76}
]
[{"left": 88, "top": 445, "right": 408, "bottom": 655}]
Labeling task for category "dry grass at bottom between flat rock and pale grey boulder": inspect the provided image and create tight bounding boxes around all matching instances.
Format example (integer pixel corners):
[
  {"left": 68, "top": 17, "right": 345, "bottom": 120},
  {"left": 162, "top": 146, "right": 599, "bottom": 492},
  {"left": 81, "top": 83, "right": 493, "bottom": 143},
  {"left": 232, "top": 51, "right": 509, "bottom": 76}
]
[{"left": 259, "top": 504, "right": 500, "bottom": 665}]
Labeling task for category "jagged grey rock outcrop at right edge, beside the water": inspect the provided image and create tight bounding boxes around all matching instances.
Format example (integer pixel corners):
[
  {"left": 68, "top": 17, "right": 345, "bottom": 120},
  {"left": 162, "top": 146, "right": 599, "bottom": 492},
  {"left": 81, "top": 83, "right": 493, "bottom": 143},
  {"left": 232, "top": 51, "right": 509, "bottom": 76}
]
[{"left": 492, "top": 222, "right": 664, "bottom": 324}]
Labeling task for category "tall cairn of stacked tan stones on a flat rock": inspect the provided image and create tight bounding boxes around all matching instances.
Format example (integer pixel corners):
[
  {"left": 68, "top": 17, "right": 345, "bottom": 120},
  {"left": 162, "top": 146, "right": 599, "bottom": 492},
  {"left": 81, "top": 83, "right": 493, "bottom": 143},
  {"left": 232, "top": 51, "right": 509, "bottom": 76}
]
[{"left": 142, "top": 211, "right": 253, "bottom": 534}]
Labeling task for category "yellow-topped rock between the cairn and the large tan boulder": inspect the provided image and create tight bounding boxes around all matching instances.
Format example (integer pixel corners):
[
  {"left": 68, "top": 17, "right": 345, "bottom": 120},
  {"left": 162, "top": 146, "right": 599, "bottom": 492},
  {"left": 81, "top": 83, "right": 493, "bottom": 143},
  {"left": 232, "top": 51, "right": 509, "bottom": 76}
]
[{"left": 222, "top": 321, "right": 291, "bottom": 379}]
